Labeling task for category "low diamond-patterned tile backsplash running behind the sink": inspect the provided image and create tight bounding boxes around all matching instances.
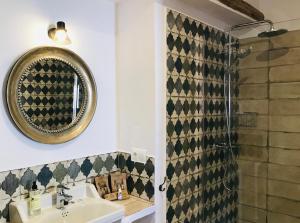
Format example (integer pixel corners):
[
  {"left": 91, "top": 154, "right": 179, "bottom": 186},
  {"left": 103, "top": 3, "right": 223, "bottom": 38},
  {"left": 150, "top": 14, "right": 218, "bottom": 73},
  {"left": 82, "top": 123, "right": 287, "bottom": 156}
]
[{"left": 0, "top": 152, "right": 154, "bottom": 223}]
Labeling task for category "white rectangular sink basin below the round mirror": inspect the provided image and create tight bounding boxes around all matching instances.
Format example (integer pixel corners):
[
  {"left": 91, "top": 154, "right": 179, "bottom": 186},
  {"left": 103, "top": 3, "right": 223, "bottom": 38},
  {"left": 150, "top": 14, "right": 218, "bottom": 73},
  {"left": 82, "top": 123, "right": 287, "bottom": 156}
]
[{"left": 9, "top": 184, "right": 125, "bottom": 223}]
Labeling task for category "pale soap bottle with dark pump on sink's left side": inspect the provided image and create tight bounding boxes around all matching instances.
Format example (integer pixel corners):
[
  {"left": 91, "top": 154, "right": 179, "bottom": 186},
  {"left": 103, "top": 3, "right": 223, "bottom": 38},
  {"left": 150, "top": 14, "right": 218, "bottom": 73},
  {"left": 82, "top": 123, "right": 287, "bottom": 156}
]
[{"left": 29, "top": 181, "right": 41, "bottom": 216}]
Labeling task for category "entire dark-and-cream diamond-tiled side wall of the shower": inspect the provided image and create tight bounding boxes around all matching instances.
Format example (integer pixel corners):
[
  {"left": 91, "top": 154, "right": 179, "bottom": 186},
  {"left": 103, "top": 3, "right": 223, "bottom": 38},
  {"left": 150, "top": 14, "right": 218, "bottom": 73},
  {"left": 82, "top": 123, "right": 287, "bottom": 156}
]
[{"left": 166, "top": 10, "right": 238, "bottom": 223}]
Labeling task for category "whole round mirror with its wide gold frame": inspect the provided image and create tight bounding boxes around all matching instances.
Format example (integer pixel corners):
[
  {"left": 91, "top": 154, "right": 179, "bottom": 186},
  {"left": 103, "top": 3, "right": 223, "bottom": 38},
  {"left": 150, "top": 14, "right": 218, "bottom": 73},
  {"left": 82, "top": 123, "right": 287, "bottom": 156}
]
[{"left": 6, "top": 47, "right": 96, "bottom": 144}]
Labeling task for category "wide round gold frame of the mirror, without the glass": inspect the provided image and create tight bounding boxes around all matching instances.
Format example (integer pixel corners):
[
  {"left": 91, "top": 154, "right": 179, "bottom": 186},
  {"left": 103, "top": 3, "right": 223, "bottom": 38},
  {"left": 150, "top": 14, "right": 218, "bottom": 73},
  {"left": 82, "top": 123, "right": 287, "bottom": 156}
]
[{"left": 6, "top": 47, "right": 97, "bottom": 144}]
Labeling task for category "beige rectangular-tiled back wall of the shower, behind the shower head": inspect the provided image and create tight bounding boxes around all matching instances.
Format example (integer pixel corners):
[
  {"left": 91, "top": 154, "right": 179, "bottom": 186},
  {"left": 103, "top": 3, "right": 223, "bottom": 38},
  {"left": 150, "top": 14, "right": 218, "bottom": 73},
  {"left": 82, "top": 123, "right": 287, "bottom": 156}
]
[{"left": 232, "top": 17, "right": 300, "bottom": 223}]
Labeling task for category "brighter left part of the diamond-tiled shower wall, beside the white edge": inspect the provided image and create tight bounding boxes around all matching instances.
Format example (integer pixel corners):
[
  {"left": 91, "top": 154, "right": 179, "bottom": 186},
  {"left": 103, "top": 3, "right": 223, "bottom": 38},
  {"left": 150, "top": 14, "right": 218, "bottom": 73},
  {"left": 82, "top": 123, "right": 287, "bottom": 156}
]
[{"left": 167, "top": 11, "right": 204, "bottom": 222}]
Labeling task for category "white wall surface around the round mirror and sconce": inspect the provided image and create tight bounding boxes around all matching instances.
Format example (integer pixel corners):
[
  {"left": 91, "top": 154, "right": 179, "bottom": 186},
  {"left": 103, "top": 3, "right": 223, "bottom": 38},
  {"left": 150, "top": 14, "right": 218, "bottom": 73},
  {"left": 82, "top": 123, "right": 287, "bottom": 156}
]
[{"left": 0, "top": 0, "right": 117, "bottom": 171}]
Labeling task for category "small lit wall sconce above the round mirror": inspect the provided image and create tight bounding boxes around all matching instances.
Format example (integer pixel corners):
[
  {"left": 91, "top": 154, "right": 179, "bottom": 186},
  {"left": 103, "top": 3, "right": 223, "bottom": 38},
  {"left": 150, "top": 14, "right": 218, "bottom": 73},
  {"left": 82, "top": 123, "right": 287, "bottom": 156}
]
[{"left": 48, "top": 21, "right": 71, "bottom": 44}]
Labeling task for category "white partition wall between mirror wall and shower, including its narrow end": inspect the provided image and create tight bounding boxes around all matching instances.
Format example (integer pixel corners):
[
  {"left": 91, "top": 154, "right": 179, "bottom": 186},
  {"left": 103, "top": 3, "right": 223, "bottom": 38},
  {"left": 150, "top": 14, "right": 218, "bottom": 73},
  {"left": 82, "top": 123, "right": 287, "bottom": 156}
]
[{"left": 117, "top": 0, "right": 166, "bottom": 222}]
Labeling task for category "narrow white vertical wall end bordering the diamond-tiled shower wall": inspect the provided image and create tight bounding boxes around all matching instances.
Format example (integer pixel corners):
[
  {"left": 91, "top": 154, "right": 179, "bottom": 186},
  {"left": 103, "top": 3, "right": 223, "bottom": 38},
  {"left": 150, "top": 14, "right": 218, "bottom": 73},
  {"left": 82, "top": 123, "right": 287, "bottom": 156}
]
[{"left": 154, "top": 3, "right": 167, "bottom": 223}]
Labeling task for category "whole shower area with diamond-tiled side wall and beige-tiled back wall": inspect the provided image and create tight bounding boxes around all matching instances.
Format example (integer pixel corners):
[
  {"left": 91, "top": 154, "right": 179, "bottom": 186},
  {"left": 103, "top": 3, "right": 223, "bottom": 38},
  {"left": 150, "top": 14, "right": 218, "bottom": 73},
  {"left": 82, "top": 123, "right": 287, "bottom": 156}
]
[{"left": 166, "top": 7, "right": 300, "bottom": 223}]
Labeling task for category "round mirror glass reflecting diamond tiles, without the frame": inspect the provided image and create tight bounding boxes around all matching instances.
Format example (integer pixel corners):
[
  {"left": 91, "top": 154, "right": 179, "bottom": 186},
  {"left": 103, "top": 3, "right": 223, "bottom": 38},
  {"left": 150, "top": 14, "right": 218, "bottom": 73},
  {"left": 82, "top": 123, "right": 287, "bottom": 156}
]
[{"left": 18, "top": 58, "right": 84, "bottom": 132}]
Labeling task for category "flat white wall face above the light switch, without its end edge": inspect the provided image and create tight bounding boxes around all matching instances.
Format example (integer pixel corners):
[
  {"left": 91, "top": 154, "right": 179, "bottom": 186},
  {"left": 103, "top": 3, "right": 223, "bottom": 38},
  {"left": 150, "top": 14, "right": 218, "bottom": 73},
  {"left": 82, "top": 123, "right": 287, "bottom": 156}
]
[{"left": 117, "top": 0, "right": 155, "bottom": 155}]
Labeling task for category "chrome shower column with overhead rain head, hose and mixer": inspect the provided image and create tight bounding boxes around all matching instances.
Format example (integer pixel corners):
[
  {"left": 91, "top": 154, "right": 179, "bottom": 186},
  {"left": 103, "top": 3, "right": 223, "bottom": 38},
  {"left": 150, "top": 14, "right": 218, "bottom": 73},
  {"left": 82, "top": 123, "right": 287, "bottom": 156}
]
[{"left": 221, "top": 20, "right": 288, "bottom": 191}]
